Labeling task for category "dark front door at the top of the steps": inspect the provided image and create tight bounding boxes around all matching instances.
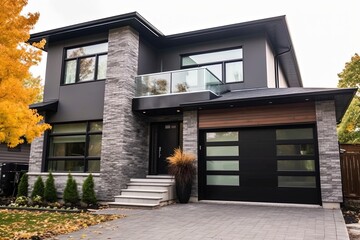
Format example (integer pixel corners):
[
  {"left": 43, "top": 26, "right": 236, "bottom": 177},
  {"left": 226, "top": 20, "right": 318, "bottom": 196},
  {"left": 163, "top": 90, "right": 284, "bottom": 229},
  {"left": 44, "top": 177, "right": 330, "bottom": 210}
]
[{"left": 150, "top": 122, "right": 180, "bottom": 174}]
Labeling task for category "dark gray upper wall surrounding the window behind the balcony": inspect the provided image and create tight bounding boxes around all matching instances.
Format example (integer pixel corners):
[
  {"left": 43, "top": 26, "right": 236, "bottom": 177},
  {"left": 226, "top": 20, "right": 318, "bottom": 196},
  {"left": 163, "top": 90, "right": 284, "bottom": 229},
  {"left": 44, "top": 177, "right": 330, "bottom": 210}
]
[{"left": 159, "top": 35, "right": 267, "bottom": 89}]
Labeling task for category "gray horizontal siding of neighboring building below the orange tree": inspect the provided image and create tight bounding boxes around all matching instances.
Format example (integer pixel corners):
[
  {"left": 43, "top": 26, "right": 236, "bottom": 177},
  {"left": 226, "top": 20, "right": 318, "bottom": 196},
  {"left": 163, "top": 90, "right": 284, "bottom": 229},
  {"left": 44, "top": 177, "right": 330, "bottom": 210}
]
[{"left": 0, "top": 144, "right": 30, "bottom": 163}]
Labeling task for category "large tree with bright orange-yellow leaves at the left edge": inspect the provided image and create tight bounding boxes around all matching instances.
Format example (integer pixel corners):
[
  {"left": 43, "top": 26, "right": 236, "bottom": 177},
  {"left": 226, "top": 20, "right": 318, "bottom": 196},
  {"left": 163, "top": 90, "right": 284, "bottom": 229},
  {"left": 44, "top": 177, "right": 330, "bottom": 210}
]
[{"left": 0, "top": 0, "right": 50, "bottom": 147}]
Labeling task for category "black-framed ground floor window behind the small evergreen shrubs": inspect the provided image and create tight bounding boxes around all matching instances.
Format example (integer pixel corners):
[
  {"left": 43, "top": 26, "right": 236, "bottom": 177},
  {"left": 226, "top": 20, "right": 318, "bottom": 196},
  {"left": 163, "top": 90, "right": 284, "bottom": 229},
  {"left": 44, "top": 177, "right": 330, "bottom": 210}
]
[{"left": 47, "top": 121, "right": 102, "bottom": 172}]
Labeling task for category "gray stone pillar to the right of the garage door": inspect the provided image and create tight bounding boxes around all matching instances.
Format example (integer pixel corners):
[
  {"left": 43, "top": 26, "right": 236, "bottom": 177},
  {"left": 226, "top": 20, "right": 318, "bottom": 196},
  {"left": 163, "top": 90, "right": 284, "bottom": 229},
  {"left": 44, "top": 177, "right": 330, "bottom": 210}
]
[{"left": 315, "top": 101, "right": 343, "bottom": 204}]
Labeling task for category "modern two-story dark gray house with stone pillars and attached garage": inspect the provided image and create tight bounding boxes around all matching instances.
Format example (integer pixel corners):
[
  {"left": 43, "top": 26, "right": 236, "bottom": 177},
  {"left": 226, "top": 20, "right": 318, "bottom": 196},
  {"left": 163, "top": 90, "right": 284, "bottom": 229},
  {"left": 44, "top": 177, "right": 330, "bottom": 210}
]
[{"left": 29, "top": 13, "right": 355, "bottom": 207}]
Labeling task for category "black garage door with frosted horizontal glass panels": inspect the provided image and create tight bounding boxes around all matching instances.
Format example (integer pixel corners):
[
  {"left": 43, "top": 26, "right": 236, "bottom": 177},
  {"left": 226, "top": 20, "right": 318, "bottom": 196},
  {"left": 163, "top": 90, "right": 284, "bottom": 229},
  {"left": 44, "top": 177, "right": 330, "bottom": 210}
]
[{"left": 199, "top": 126, "right": 320, "bottom": 204}]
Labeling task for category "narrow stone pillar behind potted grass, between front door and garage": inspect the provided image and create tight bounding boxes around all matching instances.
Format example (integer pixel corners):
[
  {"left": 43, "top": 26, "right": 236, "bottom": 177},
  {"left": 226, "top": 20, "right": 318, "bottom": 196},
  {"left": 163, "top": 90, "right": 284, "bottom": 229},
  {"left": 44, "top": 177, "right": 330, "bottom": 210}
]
[{"left": 183, "top": 111, "right": 198, "bottom": 198}]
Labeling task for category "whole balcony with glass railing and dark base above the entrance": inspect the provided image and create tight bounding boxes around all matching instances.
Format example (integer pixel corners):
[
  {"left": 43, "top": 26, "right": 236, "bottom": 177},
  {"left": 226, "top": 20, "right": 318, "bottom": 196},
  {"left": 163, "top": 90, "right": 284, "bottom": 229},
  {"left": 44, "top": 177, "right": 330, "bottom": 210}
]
[{"left": 133, "top": 68, "right": 225, "bottom": 114}]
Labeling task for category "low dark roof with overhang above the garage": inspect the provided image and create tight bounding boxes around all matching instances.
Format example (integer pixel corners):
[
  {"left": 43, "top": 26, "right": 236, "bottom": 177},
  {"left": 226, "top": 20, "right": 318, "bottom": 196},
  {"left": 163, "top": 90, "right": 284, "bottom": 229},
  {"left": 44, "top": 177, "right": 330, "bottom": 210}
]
[{"left": 180, "top": 88, "right": 357, "bottom": 123}]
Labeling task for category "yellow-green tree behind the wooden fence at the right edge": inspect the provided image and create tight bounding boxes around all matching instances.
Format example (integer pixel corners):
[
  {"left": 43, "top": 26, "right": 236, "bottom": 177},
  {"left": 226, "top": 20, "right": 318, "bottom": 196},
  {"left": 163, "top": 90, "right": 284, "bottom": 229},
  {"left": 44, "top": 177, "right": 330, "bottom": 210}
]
[{"left": 338, "top": 54, "right": 360, "bottom": 143}]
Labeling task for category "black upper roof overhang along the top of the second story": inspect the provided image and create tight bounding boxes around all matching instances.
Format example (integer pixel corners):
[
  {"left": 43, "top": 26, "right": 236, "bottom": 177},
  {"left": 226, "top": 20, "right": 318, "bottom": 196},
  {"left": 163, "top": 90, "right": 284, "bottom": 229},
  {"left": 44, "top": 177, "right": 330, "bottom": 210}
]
[{"left": 29, "top": 12, "right": 303, "bottom": 87}]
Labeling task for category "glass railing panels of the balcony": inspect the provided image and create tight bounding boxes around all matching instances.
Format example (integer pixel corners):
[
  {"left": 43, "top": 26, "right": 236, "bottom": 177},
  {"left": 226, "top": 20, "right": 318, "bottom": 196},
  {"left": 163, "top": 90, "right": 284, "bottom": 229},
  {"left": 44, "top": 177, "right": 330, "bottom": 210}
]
[{"left": 135, "top": 68, "right": 223, "bottom": 97}]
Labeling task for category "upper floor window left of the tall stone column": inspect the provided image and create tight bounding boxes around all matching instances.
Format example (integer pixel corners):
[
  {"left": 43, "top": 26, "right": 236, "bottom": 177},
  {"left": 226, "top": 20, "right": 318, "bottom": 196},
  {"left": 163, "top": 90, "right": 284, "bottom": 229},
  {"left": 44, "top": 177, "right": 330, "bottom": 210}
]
[{"left": 63, "top": 42, "right": 108, "bottom": 84}]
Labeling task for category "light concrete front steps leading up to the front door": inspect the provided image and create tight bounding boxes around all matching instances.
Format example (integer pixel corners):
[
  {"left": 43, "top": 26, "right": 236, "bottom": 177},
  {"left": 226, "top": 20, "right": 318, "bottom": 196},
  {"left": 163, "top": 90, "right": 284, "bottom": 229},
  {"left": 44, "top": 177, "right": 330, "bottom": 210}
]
[{"left": 108, "top": 175, "right": 175, "bottom": 208}]
